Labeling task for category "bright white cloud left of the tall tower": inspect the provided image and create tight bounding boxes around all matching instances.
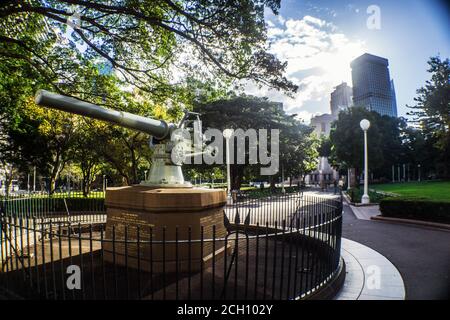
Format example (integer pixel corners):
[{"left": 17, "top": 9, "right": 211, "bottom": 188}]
[{"left": 245, "top": 15, "right": 365, "bottom": 120}]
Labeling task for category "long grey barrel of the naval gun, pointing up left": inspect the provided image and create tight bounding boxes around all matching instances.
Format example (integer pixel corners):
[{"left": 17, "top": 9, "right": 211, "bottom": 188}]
[{"left": 35, "top": 90, "right": 174, "bottom": 139}]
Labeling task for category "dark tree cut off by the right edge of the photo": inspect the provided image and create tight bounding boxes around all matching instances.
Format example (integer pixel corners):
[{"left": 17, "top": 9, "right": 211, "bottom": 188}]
[{"left": 408, "top": 56, "right": 450, "bottom": 178}]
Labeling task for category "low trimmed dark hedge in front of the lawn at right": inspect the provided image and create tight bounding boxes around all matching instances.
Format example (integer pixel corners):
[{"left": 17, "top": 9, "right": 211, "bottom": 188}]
[{"left": 380, "top": 197, "right": 450, "bottom": 224}]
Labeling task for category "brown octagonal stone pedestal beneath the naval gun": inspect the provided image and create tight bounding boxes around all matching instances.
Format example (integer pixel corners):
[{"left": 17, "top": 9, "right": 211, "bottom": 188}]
[{"left": 104, "top": 186, "right": 226, "bottom": 273}]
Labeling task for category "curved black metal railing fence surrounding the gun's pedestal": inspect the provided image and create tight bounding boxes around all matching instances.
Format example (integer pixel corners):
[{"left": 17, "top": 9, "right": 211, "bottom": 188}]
[{"left": 0, "top": 193, "right": 342, "bottom": 300}]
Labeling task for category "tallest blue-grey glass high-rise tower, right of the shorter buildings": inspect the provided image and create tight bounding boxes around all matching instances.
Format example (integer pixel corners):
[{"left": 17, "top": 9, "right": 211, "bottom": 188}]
[{"left": 350, "top": 53, "right": 397, "bottom": 117}]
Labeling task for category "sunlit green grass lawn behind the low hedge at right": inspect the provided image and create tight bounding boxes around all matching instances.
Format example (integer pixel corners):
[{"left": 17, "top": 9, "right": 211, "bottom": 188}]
[{"left": 370, "top": 181, "right": 450, "bottom": 201}]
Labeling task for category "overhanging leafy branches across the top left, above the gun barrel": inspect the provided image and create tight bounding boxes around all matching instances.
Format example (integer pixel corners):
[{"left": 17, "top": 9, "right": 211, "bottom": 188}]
[{"left": 0, "top": 0, "right": 297, "bottom": 100}]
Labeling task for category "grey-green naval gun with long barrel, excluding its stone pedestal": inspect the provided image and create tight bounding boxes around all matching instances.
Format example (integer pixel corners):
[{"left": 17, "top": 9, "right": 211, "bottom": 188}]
[{"left": 35, "top": 90, "right": 213, "bottom": 188}]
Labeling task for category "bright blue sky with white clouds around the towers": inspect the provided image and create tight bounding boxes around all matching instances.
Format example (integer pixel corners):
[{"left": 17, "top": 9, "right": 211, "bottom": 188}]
[{"left": 245, "top": 0, "right": 450, "bottom": 123}]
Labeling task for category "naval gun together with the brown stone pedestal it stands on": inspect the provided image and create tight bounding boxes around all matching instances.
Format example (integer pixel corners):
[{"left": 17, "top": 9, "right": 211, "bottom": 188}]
[{"left": 36, "top": 90, "right": 226, "bottom": 273}]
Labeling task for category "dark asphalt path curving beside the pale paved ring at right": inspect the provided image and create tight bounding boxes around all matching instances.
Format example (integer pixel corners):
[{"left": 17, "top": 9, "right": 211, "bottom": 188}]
[{"left": 343, "top": 203, "right": 450, "bottom": 299}]
